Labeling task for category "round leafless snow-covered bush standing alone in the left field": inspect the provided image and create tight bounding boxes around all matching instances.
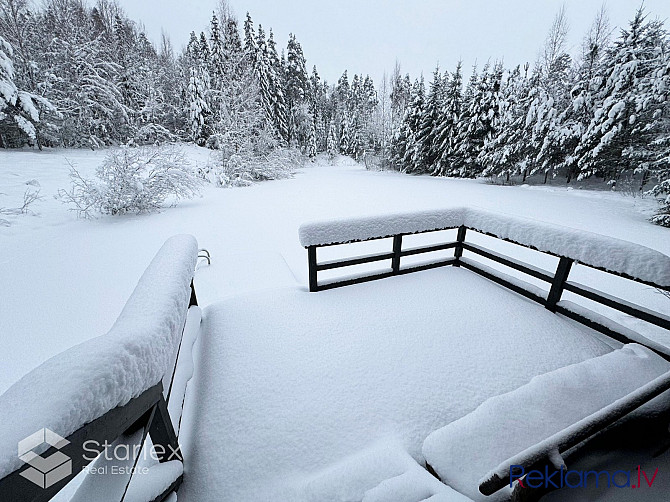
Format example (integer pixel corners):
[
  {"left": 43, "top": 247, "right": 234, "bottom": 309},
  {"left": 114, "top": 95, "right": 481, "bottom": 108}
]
[{"left": 58, "top": 147, "right": 202, "bottom": 217}]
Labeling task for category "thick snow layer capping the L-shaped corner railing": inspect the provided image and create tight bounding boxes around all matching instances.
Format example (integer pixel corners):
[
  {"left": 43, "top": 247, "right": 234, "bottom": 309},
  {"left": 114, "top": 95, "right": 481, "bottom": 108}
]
[{"left": 299, "top": 207, "right": 670, "bottom": 287}]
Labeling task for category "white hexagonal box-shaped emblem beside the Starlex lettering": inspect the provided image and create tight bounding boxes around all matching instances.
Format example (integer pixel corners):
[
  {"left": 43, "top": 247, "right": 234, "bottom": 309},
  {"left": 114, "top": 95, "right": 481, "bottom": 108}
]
[{"left": 18, "top": 428, "right": 72, "bottom": 488}]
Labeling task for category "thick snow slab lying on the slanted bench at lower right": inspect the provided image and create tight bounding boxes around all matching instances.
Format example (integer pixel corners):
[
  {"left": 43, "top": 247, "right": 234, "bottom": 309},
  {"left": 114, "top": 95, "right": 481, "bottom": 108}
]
[{"left": 423, "top": 344, "right": 670, "bottom": 500}]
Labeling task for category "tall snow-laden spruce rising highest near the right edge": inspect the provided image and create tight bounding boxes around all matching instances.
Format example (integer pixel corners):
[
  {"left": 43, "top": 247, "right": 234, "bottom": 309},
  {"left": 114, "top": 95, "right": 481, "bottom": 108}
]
[{"left": 575, "top": 8, "right": 667, "bottom": 183}]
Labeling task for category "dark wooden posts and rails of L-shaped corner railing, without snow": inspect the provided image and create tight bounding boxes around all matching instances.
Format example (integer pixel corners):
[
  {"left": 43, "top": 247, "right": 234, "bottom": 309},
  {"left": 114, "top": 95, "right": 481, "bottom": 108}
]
[{"left": 307, "top": 225, "right": 670, "bottom": 360}]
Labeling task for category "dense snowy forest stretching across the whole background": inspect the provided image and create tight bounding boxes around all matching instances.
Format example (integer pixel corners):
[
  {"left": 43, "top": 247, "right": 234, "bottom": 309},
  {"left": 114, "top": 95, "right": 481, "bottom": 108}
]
[{"left": 0, "top": 0, "right": 670, "bottom": 226}]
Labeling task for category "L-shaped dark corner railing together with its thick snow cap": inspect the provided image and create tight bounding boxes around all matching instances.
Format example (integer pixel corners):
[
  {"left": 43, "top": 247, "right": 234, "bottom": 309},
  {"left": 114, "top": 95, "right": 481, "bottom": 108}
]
[{"left": 299, "top": 207, "right": 670, "bottom": 359}]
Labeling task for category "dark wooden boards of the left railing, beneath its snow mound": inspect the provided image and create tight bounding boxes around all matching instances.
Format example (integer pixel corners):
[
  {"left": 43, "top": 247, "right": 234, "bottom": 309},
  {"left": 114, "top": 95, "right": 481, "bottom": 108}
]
[{"left": 0, "top": 243, "right": 210, "bottom": 502}]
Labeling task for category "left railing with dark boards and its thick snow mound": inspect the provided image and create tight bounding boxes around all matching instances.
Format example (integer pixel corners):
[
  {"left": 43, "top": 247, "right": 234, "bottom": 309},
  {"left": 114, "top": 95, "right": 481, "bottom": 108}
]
[{"left": 0, "top": 235, "right": 199, "bottom": 502}]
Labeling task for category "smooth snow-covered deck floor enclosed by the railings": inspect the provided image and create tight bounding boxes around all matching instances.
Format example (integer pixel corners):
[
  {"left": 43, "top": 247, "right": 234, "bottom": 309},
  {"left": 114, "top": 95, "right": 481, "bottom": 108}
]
[{"left": 179, "top": 267, "right": 611, "bottom": 501}]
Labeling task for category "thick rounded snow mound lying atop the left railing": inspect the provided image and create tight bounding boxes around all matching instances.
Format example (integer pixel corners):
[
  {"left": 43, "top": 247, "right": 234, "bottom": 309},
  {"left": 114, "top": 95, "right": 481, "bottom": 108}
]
[{"left": 0, "top": 235, "right": 198, "bottom": 478}]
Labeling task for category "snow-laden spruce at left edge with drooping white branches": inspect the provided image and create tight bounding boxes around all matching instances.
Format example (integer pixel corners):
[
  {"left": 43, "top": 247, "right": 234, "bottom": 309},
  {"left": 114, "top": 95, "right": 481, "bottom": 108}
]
[{"left": 0, "top": 36, "right": 57, "bottom": 148}]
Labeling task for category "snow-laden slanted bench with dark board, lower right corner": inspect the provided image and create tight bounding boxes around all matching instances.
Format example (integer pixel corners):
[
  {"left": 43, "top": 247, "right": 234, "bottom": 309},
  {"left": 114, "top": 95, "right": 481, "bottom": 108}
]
[{"left": 423, "top": 344, "right": 670, "bottom": 500}]
